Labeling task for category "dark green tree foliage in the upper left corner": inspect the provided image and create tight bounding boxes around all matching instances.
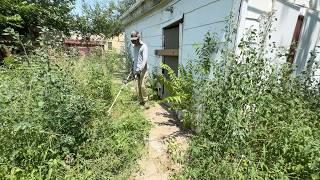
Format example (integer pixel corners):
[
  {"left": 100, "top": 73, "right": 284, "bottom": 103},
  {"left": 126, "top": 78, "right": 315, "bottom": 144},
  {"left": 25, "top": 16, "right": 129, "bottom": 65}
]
[{"left": 0, "top": 0, "right": 74, "bottom": 39}]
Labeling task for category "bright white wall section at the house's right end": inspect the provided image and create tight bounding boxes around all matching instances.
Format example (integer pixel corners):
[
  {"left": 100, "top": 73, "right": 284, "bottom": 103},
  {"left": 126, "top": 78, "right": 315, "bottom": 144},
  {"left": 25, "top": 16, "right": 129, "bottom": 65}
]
[{"left": 238, "top": 0, "right": 320, "bottom": 77}]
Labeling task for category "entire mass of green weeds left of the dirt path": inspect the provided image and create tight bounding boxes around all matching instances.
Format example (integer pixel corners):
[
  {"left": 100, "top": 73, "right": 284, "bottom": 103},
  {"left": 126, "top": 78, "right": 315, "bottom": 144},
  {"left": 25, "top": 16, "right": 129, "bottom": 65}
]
[{"left": 0, "top": 49, "right": 149, "bottom": 179}]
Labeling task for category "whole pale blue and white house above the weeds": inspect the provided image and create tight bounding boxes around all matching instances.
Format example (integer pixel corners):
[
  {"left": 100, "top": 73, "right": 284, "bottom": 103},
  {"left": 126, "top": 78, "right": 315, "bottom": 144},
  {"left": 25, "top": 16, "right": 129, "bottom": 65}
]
[{"left": 122, "top": 0, "right": 320, "bottom": 83}]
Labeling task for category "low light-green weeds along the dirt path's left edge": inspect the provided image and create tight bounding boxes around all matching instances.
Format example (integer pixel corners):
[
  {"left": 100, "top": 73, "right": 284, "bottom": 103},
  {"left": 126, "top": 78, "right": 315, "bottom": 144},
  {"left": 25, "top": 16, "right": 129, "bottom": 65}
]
[{"left": 81, "top": 87, "right": 150, "bottom": 179}]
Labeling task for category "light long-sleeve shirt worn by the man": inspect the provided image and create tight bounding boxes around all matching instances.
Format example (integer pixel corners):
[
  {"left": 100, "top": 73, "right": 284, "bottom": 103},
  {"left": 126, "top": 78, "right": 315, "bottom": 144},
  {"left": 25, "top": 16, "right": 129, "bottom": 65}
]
[{"left": 133, "top": 41, "right": 148, "bottom": 72}]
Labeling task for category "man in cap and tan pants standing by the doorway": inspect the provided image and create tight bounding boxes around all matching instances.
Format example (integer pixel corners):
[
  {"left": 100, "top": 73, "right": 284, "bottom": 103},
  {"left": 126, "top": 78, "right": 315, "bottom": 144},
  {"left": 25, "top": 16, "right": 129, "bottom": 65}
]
[{"left": 131, "top": 31, "right": 149, "bottom": 109}]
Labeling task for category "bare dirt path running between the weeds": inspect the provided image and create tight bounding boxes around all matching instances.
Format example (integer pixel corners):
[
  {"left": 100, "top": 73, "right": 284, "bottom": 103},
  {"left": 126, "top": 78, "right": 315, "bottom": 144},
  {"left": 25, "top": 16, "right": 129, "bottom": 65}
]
[{"left": 134, "top": 104, "right": 188, "bottom": 180}]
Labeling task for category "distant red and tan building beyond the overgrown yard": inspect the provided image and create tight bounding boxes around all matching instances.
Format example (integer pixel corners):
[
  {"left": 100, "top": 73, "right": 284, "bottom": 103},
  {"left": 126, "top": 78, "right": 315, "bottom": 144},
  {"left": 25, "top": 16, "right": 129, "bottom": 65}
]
[{"left": 64, "top": 35, "right": 124, "bottom": 56}]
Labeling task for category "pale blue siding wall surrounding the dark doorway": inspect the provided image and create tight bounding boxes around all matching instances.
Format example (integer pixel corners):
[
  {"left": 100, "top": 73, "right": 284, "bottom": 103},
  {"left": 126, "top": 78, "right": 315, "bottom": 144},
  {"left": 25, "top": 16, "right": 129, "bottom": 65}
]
[{"left": 125, "top": 0, "right": 240, "bottom": 71}]
